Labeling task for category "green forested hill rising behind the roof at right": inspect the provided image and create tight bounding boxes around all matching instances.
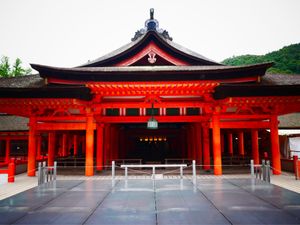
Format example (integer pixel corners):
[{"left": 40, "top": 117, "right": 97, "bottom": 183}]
[{"left": 222, "top": 43, "right": 300, "bottom": 74}]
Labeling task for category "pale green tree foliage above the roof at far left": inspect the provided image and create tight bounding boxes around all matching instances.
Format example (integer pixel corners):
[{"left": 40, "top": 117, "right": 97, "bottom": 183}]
[{"left": 0, "top": 56, "right": 31, "bottom": 77}]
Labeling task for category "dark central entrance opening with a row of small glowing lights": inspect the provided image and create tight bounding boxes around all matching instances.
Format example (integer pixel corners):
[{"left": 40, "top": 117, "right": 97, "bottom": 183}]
[{"left": 121, "top": 123, "right": 187, "bottom": 163}]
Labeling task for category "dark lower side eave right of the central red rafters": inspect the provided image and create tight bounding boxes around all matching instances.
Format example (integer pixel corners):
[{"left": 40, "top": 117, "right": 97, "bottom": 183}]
[{"left": 213, "top": 84, "right": 300, "bottom": 99}]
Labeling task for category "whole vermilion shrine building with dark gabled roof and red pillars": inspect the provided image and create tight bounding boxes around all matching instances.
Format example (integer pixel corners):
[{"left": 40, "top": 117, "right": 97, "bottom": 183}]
[{"left": 0, "top": 10, "right": 300, "bottom": 176}]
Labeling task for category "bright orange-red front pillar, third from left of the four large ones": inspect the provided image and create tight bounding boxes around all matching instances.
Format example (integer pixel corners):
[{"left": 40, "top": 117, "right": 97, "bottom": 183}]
[{"left": 212, "top": 114, "right": 222, "bottom": 175}]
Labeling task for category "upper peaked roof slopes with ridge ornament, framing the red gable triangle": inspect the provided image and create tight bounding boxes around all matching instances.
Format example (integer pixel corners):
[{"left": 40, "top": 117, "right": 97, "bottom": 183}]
[{"left": 79, "top": 9, "right": 222, "bottom": 67}]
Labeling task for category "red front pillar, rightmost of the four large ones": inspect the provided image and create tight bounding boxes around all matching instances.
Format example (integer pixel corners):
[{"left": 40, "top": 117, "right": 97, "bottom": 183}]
[{"left": 270, "top": 115, "right": 281, "bottom": 175}]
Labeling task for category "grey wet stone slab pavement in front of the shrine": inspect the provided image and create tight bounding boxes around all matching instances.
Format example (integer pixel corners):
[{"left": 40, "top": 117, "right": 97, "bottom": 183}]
[{"left": 0, "top": 178, "right": 300, "bottom": 225}]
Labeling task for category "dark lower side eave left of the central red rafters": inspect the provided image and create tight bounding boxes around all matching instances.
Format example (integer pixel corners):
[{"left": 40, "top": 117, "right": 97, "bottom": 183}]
[{"left": 0, "top": 85, "right": 92, "bottom": 100}]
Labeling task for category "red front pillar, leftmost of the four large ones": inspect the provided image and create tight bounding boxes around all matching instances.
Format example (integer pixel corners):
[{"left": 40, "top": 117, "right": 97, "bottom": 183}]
[{"left": 27, "top": 117, "right": 36, "bottom": 177}]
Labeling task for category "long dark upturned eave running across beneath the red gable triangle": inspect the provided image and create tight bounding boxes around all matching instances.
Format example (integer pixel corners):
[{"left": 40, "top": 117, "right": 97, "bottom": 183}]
[{"left": 31, "top": 63, "right": 272, "bottom": 82}]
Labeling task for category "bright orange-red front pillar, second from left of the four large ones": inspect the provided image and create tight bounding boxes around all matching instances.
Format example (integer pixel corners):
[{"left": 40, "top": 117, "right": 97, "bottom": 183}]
[{"left": 85, "top": 115, "right": 94, "bottom": 176}]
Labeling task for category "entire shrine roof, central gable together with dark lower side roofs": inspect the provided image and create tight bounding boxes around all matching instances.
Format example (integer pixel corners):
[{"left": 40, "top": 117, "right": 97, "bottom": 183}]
[{"left": 0, "top": 9, "right": 300, "bottom": 100}]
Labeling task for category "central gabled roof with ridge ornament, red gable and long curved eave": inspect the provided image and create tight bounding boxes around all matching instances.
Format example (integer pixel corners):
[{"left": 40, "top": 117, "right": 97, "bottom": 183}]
[{"left": 31, "top": 10, "right": 272, "bottom": 84}]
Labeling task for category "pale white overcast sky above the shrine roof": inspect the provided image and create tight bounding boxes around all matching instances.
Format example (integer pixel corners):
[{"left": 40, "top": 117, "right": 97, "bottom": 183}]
[{"left": 0, "top": 0, "right": 300, "bottom": 70}]
